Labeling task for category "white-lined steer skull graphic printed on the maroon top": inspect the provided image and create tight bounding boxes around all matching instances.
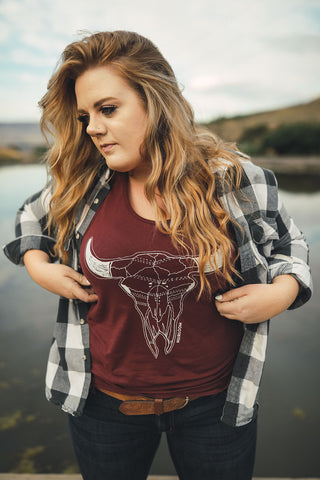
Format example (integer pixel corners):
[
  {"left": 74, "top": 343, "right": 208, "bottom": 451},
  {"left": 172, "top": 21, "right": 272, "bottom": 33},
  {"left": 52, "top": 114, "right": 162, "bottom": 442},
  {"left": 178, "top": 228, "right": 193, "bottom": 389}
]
[{"left": 85, "top": 238, "right": 198, "bottom": 358}]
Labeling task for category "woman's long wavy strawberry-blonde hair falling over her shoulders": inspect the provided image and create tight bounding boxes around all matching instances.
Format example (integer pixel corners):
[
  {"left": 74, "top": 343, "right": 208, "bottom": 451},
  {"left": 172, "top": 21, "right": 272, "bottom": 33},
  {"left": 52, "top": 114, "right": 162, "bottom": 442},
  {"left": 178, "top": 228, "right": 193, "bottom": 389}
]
[{"left": 39, "top": 31, "right": 245, "bottom": 296}]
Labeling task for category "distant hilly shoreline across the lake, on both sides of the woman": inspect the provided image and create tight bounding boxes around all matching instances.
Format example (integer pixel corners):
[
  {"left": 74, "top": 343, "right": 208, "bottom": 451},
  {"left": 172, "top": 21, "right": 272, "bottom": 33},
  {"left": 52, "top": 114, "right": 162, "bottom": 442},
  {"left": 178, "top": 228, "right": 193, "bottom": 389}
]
[{"left": 0, "top": 94, "right": 320, "bottom": 176}]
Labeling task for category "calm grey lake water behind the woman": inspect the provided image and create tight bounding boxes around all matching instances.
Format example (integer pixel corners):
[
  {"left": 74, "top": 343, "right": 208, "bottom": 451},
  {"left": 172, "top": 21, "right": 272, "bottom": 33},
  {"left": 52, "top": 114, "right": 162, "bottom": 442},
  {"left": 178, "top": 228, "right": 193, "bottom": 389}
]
[{"left": 0, "top": 166, "right": 320, "bottom": 477}]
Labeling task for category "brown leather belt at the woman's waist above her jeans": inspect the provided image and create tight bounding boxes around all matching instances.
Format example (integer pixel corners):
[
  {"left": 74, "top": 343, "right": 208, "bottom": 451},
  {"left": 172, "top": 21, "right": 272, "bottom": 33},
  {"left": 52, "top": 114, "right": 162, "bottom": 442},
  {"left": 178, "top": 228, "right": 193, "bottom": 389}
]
[{"left": 99, "top": 388, "right": 199, "bottom": 415}]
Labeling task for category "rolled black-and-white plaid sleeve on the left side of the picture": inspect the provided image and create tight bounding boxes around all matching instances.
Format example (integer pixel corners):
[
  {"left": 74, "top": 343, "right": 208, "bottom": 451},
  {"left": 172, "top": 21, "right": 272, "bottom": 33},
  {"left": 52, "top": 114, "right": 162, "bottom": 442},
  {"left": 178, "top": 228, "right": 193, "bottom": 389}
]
[{"left": 3, "top": 187, "right": 55, "bottom": 265}]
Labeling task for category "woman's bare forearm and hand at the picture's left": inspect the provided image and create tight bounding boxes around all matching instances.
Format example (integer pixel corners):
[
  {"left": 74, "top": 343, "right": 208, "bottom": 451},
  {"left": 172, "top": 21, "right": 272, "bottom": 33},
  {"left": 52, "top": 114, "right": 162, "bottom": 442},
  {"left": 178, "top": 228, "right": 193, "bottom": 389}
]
[{"left": 23, "top": 250, "right": 98, "bottom": 303}]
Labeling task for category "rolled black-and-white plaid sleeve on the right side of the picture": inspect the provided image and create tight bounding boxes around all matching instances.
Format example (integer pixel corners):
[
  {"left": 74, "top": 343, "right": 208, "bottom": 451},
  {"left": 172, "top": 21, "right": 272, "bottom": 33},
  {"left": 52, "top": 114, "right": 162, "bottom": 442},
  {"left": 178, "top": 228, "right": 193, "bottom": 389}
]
[{"left": 221, "top": 162, "right": 312, "bottom": 309}]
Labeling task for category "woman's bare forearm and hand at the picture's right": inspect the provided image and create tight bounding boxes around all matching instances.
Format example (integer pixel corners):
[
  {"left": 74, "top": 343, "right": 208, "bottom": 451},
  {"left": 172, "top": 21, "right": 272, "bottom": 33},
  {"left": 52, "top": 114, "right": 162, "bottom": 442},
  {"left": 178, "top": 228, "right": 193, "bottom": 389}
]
[{"left": 215, "top": 275, "right": 299, "bottom": 323}]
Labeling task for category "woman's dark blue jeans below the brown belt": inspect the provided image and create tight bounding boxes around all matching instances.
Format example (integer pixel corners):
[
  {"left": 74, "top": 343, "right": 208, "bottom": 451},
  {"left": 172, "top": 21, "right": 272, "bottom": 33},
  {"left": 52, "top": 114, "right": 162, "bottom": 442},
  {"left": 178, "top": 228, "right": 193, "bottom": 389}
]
[{"left": 69, "top": 389, "right": 257, "bottom": 480}]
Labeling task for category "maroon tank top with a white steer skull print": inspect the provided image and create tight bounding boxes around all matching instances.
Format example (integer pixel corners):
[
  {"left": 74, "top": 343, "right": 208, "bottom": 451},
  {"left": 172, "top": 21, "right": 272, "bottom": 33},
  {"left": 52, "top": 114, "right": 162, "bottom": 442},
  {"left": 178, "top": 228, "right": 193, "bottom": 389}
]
[{"left": 80, "top": 174, "right": 243, "bottom": 398}]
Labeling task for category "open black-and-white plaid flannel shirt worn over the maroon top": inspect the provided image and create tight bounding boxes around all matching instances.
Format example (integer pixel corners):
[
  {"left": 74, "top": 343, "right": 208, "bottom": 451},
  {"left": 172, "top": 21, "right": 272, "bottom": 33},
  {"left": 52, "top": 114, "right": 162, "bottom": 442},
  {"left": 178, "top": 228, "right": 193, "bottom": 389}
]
[{"left": 4, "top": 161, "right": 312, "bottom": 426}]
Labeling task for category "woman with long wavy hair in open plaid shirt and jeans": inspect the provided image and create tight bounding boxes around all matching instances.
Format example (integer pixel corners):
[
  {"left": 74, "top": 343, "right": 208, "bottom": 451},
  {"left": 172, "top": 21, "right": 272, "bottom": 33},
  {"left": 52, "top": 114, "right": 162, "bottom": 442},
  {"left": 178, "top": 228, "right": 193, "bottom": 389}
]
[{"left": 5, "top": 31, "right": 311, "bottom": 480}]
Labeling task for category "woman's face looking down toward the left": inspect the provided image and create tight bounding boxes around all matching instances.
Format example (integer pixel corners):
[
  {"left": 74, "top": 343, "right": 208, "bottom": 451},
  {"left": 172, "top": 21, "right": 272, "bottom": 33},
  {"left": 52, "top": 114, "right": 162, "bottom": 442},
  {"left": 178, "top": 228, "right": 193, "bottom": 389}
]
[{"left": 75, "top": 66, "right": 150, "bottom": 179}]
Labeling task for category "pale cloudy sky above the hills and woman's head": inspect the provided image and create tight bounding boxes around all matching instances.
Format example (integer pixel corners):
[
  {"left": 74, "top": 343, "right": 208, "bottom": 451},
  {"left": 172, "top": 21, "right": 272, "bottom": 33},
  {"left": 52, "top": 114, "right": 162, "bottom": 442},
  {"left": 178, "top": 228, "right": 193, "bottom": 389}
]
[{"left": 0, "top": 0, "right": 320, "bottom": 122}]
